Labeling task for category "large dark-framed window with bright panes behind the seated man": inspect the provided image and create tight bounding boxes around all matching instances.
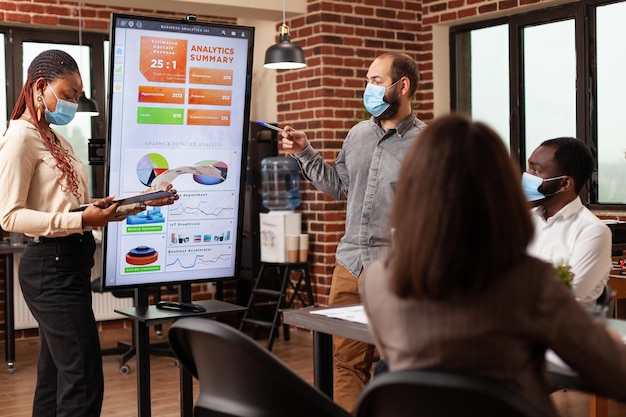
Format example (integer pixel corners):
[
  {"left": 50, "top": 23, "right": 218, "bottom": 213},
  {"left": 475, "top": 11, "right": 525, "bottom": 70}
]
[{"left": 450, "top": 0, "right": 626, "bottom": 209}]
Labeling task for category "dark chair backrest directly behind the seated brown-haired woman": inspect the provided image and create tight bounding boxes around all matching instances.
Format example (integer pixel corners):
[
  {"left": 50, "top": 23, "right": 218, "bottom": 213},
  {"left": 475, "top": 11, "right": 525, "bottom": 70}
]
[{"left": 356, "top": 370, "right": 547, "bottom": 417}]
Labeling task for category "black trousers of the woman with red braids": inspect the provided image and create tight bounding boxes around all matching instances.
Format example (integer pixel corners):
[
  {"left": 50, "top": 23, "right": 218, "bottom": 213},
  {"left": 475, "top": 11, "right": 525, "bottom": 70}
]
[{"left": 19, "top": 233, "right": 104, "bottom": 417}]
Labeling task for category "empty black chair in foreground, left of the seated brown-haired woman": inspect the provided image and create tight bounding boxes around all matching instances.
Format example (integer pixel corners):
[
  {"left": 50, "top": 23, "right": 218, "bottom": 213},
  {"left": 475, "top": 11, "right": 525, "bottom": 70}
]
[{"left": 168, "top": 317, "right": 350, "bottom": 417}]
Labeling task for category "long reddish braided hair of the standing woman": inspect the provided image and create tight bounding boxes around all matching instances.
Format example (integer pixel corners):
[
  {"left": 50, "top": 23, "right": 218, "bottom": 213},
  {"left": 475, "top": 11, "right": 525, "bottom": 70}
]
[{"left": 10, "top": 49, "right": 80, "bottom": 198}]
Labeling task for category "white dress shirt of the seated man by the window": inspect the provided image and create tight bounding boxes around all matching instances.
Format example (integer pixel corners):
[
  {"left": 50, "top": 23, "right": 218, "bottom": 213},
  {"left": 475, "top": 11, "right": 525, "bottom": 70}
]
[{"left": 528, "top": 197, "right": 611, "bottom": 306}]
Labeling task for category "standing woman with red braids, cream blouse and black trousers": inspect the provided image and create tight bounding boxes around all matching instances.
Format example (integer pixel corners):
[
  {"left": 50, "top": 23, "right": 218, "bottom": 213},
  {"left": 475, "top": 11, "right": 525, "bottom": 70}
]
[{"left": 0, "top": 50, "right": 178, "bottom": 417}]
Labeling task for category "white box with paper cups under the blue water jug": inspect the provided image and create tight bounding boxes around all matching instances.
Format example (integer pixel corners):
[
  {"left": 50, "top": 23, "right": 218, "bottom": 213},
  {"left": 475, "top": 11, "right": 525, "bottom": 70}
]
[{"left": 259, "top": 210, "right": 302, "bottom": 262}]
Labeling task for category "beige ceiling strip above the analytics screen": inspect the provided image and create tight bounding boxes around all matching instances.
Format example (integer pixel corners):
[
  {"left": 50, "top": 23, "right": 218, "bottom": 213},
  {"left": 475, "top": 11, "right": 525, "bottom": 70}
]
[{"left": 68, "top": 0, "right": 307, "bottom": 22}]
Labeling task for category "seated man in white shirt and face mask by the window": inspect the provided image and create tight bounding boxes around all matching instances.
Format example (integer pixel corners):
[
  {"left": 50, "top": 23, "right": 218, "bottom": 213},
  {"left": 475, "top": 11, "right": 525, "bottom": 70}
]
[{"left": 522, "top": 138, "right": 611, "bottom": 307}]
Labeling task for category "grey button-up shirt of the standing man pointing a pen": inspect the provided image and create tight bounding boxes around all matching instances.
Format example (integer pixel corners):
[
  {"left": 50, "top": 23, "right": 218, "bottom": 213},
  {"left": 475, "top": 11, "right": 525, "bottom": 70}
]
[{"left": 293, "top": 113, "right": 426, "bottom": 277}]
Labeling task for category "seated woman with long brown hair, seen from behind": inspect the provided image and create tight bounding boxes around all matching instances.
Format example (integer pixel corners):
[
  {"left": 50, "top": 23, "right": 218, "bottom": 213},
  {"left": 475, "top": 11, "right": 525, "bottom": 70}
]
[{"left": 360, "top": 114, "right": 626, "bottom": 416}]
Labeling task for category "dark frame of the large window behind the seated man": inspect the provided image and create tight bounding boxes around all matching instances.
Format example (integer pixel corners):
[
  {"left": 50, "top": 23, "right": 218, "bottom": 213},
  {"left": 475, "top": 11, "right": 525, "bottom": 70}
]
[{"left": 450, "top": 0, "right": 626, "bottom": 211}]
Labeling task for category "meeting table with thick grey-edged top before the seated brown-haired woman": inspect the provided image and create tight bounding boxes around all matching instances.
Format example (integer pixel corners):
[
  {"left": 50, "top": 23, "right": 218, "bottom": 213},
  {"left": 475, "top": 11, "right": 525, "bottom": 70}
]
[{"left": 283, "top": 308, "right": 626, "bottom": 417}]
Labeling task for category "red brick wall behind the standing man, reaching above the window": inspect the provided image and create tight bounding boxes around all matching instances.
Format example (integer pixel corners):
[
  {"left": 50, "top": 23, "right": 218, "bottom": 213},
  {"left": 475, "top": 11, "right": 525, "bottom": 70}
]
[{"left": 276, "top": 0, "right": 554, "bottom": 305}]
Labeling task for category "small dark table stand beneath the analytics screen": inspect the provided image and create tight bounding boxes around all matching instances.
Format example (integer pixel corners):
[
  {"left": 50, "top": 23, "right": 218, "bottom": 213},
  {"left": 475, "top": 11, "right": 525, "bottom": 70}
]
[{"left": 115, "top": 298, "right": 245, "bottom": 417}]
